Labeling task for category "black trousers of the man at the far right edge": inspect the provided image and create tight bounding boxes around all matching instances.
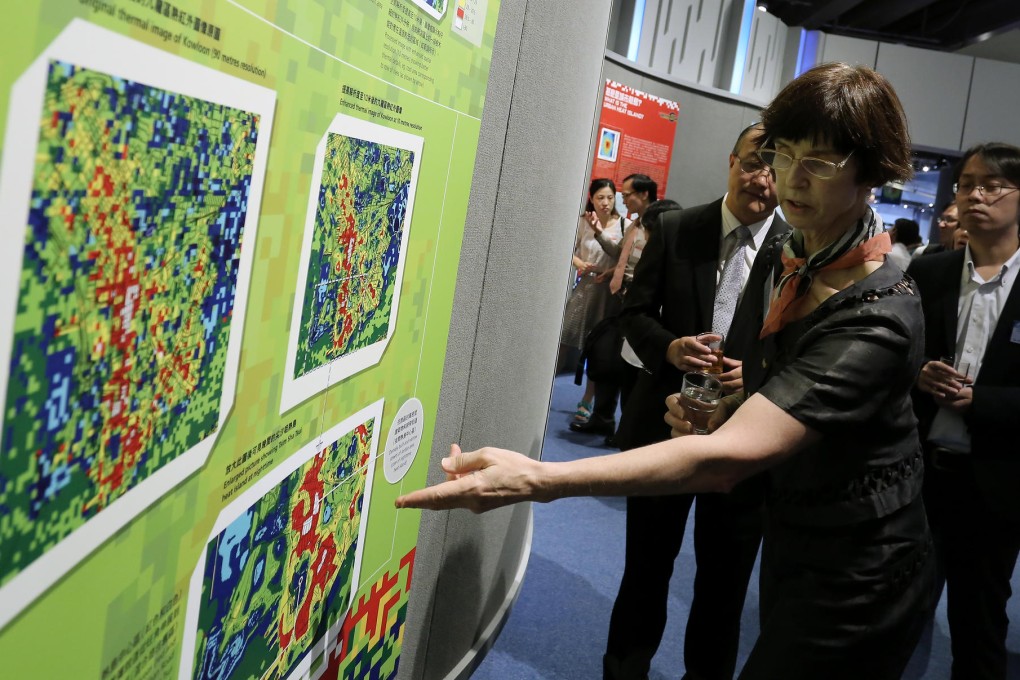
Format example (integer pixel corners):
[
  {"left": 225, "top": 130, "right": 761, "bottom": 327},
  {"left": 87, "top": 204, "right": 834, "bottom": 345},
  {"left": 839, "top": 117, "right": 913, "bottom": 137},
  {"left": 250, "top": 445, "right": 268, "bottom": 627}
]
[{"left": 924, "top": 455, "right": 1020, "bottom": 680}]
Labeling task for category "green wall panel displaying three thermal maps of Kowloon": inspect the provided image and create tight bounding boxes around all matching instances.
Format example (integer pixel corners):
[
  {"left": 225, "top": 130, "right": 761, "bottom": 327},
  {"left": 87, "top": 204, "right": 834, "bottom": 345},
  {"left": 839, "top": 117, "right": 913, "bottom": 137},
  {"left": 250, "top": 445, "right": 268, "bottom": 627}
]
[{"left": 0, "top": 0, "right": 499, "bottom": 680}]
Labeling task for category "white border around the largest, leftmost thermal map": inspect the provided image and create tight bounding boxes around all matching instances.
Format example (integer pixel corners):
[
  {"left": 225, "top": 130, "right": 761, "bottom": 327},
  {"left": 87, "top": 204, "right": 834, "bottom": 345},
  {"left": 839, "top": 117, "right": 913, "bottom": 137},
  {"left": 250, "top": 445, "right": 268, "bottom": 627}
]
[{"left": 0, "top": 19, "right": 276, "bottom": 629}]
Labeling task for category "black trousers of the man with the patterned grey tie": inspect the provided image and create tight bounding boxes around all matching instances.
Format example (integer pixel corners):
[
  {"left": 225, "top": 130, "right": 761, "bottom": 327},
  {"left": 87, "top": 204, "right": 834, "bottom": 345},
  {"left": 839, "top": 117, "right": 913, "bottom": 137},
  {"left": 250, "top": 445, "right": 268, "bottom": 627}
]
[{"left": 604, "top": 478, "right": 762, "bottom": 680}]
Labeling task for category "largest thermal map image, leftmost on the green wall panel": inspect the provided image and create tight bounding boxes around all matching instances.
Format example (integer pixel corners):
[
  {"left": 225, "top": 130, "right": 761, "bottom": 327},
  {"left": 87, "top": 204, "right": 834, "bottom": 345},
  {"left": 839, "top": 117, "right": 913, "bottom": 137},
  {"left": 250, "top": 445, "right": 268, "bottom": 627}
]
[{"left": 0, "top": 60, "right": 259, "bottom": 583}]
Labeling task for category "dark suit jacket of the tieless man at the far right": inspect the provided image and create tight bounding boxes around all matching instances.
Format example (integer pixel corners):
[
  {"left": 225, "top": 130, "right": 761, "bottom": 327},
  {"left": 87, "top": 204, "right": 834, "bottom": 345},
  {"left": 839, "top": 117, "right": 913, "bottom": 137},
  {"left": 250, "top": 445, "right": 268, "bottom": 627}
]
[{"left": 908, "top": 250, "right": 1020, "bottom": 520}]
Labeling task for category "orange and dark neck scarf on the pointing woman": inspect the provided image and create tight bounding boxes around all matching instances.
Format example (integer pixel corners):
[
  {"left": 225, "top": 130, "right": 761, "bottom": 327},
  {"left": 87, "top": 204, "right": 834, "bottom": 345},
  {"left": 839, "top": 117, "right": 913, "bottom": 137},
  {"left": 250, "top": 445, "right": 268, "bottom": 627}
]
[{"left": 759, "top": 208, "right": 893, "bottom": 337}]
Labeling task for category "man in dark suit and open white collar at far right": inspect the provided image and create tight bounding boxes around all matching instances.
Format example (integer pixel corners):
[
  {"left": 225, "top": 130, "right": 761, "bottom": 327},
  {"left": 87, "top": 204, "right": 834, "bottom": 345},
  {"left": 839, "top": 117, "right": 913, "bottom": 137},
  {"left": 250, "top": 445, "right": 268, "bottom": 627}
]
[{"left": 909, "top": 144, "right": 1020, "bottom": 680}]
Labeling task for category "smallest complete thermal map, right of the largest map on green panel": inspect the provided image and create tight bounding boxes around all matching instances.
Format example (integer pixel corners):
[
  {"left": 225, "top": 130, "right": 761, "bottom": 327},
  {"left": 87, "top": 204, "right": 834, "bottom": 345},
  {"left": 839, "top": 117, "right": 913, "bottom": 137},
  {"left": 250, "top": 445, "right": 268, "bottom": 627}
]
[{"left": 293, "top": 133, "right": 414, "bottom": 377}]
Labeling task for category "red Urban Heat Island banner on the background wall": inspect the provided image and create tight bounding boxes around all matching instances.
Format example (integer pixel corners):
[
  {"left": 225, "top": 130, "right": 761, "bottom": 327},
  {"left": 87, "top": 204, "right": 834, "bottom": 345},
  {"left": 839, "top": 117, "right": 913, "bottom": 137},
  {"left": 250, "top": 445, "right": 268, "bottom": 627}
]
[{"left": 592, "top": 81, "right": 680, "bottom": 197}]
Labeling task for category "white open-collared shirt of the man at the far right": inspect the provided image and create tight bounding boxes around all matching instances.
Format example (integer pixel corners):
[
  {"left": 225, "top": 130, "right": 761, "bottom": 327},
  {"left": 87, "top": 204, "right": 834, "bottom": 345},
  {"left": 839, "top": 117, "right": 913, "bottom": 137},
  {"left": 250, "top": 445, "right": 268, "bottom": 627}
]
[{"left": 928, "top": 244, "right": 1020, "bottom": 453}]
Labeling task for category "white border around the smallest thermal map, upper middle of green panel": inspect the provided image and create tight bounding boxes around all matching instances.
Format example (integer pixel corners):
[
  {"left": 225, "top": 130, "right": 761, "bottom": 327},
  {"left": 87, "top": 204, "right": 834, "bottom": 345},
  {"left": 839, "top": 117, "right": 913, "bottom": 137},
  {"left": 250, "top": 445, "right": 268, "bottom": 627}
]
[{"left": 279, "top": 113, "right": 424, "bottom": 414}]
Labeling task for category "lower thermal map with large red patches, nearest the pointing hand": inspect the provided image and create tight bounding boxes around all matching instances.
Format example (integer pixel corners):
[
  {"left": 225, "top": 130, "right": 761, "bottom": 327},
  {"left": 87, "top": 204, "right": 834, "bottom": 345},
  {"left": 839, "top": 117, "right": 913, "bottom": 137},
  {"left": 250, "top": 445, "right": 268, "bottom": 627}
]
[{"left": 194, "top": 420, "right": 375, "bottom": 680}]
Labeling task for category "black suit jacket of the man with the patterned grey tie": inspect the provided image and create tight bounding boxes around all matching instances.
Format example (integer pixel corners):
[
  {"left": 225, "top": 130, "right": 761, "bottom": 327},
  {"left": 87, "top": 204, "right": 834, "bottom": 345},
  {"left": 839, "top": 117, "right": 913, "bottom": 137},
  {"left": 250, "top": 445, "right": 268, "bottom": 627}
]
[{"left": 616, "top": 199, "right": 789, "bottom": 449}]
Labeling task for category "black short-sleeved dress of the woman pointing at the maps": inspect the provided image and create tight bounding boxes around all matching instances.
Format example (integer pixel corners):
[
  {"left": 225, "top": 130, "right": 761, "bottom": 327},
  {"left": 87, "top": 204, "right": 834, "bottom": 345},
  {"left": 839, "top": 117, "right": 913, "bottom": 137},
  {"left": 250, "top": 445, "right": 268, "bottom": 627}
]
[{"left": 740, "top": 249, "right": 934, "bottom": 680}]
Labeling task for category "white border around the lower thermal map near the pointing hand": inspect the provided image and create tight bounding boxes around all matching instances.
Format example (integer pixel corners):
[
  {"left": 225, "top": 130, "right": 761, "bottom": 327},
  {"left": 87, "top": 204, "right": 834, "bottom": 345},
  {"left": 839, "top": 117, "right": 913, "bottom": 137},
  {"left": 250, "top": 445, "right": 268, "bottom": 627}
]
[{"left": 177, "top": 399, "right": 386, "bottom": 680}]
